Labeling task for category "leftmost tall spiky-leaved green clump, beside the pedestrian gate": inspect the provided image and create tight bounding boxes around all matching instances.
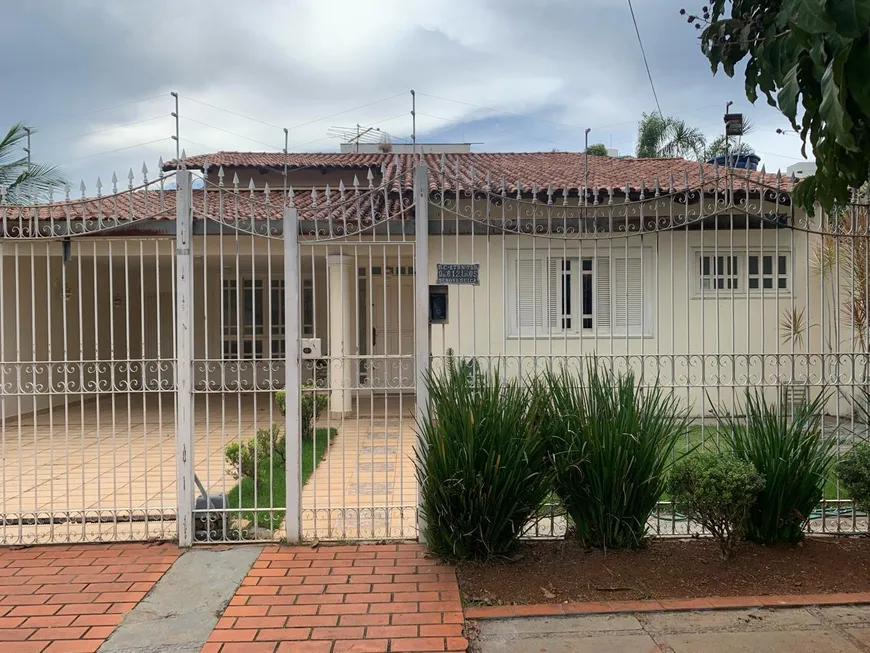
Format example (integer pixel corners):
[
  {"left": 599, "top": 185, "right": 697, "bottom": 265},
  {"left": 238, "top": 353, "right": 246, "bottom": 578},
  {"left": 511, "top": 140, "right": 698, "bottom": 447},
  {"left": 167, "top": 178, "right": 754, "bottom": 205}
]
[{"left": 415, "top": 358, "right": 551, "bottom": 560}]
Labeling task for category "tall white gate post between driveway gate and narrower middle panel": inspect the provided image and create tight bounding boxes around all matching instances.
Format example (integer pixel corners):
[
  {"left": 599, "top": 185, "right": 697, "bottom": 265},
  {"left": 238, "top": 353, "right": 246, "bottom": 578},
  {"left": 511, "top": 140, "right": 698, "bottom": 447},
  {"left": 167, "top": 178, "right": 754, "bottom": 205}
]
[{"left": 175, "top": 169, "right": 194, "bottom": 547}]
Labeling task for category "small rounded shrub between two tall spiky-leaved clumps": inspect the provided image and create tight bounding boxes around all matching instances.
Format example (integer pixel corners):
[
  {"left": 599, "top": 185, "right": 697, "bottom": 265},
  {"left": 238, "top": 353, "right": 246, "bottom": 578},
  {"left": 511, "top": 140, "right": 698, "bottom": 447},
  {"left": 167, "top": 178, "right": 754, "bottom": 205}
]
[{"left": 668, "top": 452, "right": 764, "bottom": 560}]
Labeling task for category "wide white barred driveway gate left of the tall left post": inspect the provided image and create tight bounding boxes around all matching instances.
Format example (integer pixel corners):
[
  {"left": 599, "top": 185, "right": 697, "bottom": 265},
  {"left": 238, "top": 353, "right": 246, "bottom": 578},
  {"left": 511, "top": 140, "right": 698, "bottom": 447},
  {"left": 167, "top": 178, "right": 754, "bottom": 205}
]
[{"left": 0, "top": 172, "right": 177, "bottom": 544}]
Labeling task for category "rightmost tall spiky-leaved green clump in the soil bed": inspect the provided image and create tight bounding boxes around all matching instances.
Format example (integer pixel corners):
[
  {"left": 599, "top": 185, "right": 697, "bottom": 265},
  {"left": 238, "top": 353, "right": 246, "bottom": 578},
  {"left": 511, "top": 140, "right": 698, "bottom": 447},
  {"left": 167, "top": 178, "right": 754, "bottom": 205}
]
[{"left": 716, "top": 390, "right": 836, "bottom": 544}]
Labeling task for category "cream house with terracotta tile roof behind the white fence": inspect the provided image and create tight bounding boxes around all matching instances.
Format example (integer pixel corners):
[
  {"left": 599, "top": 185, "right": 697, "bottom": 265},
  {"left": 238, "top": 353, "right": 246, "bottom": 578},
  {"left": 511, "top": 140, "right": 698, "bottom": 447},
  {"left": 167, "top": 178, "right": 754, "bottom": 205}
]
[{"left": 2, "top": 152, "right": 864, "bottom": 416}]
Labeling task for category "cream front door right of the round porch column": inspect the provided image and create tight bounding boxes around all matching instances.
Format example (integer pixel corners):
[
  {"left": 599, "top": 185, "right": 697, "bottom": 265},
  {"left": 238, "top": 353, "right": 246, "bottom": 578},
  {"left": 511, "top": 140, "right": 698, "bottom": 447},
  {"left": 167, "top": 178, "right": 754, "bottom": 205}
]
[{"left": 369, "top": 266, "right": 415, "bottom": 390}]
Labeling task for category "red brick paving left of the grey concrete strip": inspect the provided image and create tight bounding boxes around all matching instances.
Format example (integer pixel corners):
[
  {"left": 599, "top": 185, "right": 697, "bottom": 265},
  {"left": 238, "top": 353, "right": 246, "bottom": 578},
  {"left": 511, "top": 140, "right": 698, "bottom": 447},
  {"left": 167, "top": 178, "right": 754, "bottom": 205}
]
[{"left": 0, "top": 543, "right": 181, "bottom": 653}]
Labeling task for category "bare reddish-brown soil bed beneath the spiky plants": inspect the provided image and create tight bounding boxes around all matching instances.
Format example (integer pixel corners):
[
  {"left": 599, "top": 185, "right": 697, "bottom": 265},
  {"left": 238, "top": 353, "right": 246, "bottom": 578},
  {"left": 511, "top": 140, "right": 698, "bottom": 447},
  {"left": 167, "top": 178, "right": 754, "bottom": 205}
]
[{"left": 456, "top": 537, "right": 870, "bottom": 605}]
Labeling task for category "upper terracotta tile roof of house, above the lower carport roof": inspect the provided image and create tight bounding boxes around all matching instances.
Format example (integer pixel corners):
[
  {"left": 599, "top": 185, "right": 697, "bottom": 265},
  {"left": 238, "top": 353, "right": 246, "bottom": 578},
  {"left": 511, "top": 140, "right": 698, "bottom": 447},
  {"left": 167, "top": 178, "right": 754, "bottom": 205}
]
[{"left": 166, "top": 152, "right": 791, "bottom": 193}]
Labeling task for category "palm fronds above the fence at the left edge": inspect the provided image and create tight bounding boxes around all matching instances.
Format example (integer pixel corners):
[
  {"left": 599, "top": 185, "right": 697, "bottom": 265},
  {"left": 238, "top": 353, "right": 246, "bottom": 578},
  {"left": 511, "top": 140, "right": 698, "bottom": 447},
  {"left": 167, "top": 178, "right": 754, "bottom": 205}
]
[{"left": 0, "top": 122, "right": 65, "bottom": 204}]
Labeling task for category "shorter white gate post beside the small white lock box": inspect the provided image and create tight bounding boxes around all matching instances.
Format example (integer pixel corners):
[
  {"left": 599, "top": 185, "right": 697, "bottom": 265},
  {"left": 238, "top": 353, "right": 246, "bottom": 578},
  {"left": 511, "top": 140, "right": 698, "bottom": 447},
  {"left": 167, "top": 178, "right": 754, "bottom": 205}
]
[{"left": 284, "top": 206, "right": 302, "bottom": 542}]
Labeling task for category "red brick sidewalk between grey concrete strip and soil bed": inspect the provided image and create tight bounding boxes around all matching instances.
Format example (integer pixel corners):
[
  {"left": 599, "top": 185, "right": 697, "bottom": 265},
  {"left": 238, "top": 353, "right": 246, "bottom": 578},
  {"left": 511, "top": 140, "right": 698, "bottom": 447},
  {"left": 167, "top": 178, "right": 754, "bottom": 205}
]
[{"left": 202, "top": 544, "right": 468, "bottom": 653}]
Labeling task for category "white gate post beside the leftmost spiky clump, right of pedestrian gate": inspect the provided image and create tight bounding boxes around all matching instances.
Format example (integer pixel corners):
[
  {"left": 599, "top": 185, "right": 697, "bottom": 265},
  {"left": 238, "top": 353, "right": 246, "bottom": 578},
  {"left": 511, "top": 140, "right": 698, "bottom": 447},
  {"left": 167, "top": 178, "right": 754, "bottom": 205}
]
[{"left": 414, "top": 161, "right": 429, "bottom": 543}]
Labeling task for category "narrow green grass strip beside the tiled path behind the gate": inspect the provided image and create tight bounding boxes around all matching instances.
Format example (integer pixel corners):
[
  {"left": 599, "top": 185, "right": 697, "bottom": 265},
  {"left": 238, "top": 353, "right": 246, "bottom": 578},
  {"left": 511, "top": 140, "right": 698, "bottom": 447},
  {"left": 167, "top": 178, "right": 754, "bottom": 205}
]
[{"left": 226, "top": 428, "right": 337, "bottom": 530}]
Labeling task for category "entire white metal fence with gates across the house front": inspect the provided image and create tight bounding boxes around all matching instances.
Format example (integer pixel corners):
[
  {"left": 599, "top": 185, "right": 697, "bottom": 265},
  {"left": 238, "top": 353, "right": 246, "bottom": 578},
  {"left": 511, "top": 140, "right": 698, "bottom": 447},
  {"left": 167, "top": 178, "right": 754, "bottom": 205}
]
[{"left": 0, "top": 155, "right": 870, "bottom": 544}]
